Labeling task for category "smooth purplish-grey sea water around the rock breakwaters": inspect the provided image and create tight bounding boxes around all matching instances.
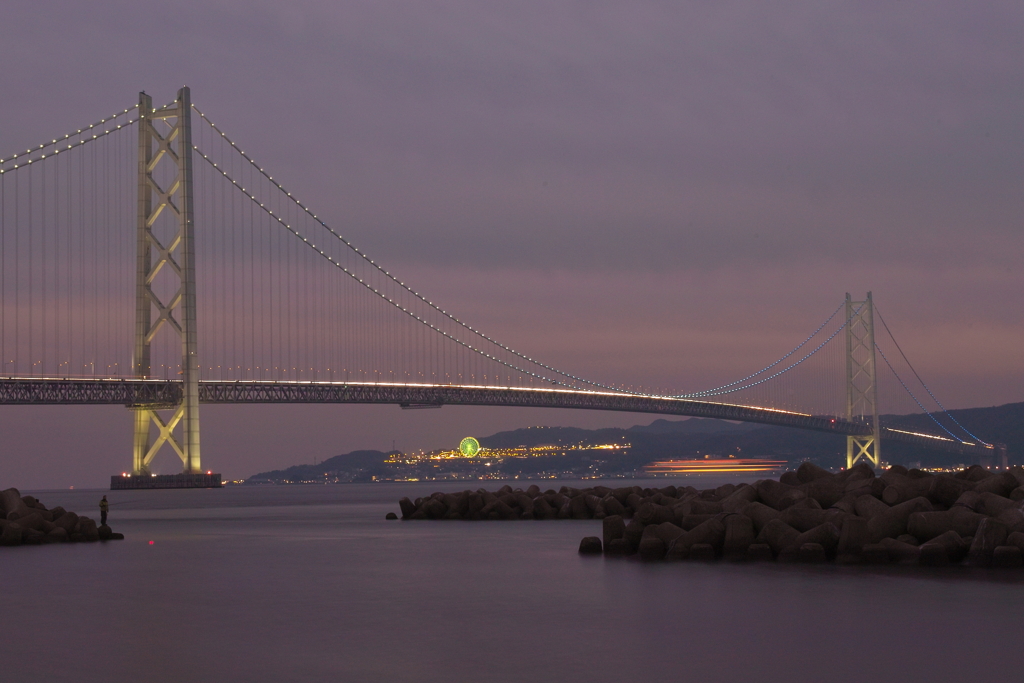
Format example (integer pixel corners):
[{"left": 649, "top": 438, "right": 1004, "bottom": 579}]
[{"left": 0, "top": 479, "right": 1024, "bottom": 683}]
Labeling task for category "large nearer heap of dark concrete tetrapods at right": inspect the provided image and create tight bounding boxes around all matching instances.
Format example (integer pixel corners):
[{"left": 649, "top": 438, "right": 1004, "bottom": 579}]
[{"left": 580, "top": 463, "right": 1024, "bottom": 567}]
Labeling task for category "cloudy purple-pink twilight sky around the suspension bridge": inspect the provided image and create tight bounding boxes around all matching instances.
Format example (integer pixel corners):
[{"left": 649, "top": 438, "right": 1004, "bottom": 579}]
[{"left": 0, "top": 0, "right": 1024, "bottom": 488}]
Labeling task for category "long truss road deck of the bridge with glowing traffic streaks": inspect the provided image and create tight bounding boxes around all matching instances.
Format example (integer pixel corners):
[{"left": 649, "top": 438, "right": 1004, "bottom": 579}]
[{"left": 0, "top": 378, "right": 991, "bottom": 455}]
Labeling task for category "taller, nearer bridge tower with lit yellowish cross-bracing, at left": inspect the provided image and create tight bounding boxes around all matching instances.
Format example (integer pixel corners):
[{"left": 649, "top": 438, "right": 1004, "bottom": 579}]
[{"left": 132, "top": 87, "right": 202, "bottom": 474}]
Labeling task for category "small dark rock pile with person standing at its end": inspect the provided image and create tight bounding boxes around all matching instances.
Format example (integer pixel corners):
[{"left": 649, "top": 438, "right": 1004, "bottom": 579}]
[{"left": 0, "top": 488, "right": 124, "bottom": 546}]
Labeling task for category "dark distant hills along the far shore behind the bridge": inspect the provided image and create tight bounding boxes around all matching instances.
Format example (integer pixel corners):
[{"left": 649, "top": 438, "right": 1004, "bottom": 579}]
[{"left": 248, "top": 402, "right": 1024, "bottom": 483}]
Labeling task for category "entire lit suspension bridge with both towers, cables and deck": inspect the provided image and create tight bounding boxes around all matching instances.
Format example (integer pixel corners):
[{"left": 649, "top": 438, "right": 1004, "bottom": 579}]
[{"left": 0, "top": 88, "right": 997, "bottom": 475}]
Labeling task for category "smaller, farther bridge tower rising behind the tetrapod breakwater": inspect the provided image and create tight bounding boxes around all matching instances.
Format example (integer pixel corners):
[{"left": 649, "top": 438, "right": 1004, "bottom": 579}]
[{"left": 846, "top": 292, "right": 882, "bottom": 469}]
